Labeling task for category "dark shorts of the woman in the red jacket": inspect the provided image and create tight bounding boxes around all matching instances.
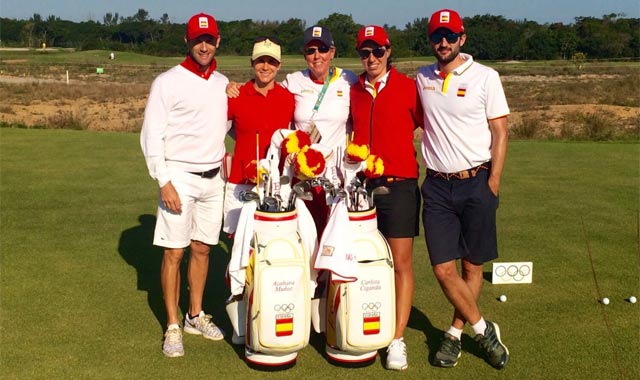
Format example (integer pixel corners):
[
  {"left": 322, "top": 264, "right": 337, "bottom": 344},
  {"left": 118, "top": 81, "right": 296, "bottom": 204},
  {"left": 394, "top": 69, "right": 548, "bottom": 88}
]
[{"left": 367, "top": 177, "right": 420, "bottom": 238}]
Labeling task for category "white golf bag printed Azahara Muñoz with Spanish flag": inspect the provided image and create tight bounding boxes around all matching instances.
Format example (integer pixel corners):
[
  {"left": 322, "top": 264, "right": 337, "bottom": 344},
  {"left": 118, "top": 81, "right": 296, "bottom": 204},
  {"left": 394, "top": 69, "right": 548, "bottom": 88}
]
[{"left": 244, "top": 210, "right": 311, "bottom": 366}]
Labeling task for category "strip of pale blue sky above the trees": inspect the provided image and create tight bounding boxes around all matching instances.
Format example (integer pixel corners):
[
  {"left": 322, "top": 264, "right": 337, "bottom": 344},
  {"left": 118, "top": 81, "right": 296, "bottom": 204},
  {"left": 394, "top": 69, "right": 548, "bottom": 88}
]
[{"left": 0, "top": 0, "right": 640, "bottom": 29}]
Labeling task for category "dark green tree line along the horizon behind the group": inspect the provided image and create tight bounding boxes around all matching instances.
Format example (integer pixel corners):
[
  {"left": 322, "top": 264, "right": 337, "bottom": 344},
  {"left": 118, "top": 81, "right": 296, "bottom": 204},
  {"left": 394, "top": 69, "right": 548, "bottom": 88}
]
[{"left": 0, "top": 9, "right": 640, "bottom": 60}]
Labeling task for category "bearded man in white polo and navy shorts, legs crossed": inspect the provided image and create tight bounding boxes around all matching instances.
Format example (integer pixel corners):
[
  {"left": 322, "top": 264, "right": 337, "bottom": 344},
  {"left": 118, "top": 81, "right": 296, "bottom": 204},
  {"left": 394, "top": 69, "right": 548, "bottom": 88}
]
[{"left": 416, "top": 9, "right": 509, "bottom": 369}]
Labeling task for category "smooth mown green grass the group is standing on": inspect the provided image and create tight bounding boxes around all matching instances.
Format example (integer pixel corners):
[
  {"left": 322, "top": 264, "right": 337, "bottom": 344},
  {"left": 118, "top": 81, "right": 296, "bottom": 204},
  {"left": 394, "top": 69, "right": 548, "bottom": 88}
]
[{"left": 0, "top": 128, "right": 640, "bottom": 379}]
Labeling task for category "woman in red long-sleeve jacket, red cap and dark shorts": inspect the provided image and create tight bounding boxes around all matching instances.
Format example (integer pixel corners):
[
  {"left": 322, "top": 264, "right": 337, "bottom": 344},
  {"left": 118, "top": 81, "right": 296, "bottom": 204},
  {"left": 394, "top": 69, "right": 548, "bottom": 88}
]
[{"left": 350, "top": 25, "right": 422, "bottom": 370}]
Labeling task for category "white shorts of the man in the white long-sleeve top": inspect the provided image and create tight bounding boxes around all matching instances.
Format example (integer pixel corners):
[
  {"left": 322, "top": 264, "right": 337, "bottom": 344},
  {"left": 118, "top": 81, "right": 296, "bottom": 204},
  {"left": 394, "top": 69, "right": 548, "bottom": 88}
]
[{"left": 153, "top": 169, "right": 224, "bottom": 248}]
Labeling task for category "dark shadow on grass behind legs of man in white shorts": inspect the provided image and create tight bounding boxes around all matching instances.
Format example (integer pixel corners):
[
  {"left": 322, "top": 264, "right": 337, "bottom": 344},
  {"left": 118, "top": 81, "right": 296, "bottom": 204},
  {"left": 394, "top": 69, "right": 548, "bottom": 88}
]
[{"left": 118, "top": 214, "right": 232, "bottom": 336}]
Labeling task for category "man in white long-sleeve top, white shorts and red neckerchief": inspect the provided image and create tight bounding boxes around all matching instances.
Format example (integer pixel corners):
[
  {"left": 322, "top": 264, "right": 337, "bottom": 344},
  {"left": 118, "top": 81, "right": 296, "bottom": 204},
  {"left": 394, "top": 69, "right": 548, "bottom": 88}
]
[{"left": 140, "top": 13, "right": 228, "bottom": 357}]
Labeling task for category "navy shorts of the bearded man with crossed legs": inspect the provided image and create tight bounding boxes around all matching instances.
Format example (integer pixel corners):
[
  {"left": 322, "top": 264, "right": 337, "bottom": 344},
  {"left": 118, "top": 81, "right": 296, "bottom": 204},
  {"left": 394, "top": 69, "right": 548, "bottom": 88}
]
[{"left": 421, "top": 169, "right": 498, "bottom": 265}]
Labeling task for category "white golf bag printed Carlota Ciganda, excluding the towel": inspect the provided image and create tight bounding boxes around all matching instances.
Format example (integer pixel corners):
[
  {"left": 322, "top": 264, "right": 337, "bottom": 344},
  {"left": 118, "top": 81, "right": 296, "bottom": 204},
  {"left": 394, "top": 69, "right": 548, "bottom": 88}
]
[{"left": 320, "top": 208, "right": 396, "bottom": 363}]
